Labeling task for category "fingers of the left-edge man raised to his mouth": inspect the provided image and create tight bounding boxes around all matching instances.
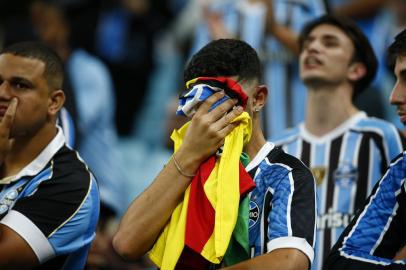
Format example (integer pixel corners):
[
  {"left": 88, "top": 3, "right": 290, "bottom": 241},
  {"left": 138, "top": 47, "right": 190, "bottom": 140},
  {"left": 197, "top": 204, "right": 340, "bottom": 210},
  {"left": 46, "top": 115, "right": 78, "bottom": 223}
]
[{"left": 0, "top": 98, "right": 18, "bottom": 164}]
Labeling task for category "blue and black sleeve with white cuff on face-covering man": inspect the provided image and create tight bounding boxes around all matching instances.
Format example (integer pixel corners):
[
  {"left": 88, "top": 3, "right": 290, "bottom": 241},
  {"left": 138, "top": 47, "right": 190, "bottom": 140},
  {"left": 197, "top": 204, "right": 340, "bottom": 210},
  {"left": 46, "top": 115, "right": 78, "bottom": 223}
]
[{"left": 267, "top": 168, "right": 316, "bottom": 262}]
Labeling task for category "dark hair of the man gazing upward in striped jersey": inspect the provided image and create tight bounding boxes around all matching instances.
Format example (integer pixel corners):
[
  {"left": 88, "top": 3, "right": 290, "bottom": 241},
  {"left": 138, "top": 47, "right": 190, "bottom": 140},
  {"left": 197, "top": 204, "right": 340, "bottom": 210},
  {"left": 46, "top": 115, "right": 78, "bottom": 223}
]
[{"left": 299, "top": 15, "right": 378, "bottom": 96}]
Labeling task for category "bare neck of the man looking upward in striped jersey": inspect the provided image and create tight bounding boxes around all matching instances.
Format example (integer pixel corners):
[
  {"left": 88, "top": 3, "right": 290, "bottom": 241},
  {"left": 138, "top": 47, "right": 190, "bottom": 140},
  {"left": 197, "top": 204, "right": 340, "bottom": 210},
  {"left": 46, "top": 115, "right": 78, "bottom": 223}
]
[{"left": 305, "top": 85, "right": 358, "bottom": 136}]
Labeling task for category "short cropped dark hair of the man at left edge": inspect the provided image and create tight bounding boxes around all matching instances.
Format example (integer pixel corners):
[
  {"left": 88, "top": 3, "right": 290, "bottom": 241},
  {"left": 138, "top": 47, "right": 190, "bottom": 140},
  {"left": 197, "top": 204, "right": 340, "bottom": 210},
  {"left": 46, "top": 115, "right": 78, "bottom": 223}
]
[{"left": 0, "top": 41, "right": 63, "bottom": 90}]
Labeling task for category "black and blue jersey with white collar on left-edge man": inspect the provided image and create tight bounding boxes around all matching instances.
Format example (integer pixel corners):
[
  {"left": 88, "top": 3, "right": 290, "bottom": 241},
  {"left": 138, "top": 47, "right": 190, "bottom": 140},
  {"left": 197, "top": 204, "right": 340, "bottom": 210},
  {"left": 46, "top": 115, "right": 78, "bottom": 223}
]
[{"left": 0, "top": 128, "right": 100, "bottom": 270}]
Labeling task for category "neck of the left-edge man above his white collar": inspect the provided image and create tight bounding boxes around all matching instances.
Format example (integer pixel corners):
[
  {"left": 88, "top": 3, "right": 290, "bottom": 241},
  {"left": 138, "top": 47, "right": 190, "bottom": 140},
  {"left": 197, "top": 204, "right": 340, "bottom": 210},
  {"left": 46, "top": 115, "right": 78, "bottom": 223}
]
[{"left": 1, "top": 123, "right": 57, "bottom": 178}]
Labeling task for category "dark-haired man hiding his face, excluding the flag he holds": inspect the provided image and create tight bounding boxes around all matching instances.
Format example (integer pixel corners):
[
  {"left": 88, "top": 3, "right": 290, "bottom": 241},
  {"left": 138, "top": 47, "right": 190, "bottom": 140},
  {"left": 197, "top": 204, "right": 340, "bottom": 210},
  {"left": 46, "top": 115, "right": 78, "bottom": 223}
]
[{"left": 113, "top": 39, "right": 316, "bottom": 269}]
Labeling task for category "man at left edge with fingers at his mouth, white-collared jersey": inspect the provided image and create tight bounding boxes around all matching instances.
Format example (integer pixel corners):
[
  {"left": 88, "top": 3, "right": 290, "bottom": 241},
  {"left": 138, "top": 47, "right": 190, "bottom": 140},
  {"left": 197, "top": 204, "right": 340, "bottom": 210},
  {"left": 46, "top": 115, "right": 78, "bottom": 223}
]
[{"left": 0, "top": 42, "right": 99, "bottom": 269}]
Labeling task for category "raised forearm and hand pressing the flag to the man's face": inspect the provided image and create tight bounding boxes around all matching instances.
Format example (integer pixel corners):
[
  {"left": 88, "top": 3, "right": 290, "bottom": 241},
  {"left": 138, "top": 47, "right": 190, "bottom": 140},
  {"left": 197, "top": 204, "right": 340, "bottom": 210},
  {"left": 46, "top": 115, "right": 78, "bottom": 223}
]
[{"left": 113, "top": 92, "right": 243, "bottom": 259}]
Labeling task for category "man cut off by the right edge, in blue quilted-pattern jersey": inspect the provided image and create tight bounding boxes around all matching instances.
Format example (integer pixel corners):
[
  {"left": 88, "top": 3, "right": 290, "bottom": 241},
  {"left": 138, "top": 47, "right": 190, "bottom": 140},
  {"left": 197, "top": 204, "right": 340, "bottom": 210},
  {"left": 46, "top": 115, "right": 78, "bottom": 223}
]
[{"left": 324, "top": 26, "right": 406, "bottom": 270}]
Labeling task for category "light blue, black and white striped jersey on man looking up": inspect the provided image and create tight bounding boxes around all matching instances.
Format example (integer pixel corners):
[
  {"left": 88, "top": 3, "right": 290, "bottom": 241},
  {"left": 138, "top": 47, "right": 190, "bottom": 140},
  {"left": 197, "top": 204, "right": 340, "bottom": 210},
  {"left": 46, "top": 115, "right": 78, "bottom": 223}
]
[{"left": 275, "top": 112, "right": 403, "bottom": 269}]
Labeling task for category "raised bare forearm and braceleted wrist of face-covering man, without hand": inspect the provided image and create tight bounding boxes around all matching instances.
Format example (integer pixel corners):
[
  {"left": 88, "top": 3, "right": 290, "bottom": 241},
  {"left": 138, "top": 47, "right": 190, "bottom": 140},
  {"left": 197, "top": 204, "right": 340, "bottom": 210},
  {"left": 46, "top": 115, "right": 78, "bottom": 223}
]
[{"left": 113, "top": 150, "right": 199, "bottom": 259}]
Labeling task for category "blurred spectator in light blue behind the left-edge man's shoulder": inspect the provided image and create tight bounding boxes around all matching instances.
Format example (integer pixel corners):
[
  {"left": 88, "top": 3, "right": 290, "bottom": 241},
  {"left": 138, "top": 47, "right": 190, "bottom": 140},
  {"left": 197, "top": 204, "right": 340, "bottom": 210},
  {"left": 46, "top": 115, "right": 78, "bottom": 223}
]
[{"left": 31, "top": 0, "right": 124, "bottom": 217}]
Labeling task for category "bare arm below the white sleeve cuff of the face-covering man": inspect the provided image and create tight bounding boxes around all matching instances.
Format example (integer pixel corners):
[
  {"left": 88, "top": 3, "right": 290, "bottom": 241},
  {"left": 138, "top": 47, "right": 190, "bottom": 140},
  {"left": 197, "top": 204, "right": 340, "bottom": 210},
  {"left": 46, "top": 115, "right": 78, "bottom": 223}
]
[{"left": 225, "top": 248, "right": 309, "bottom": 270}]
